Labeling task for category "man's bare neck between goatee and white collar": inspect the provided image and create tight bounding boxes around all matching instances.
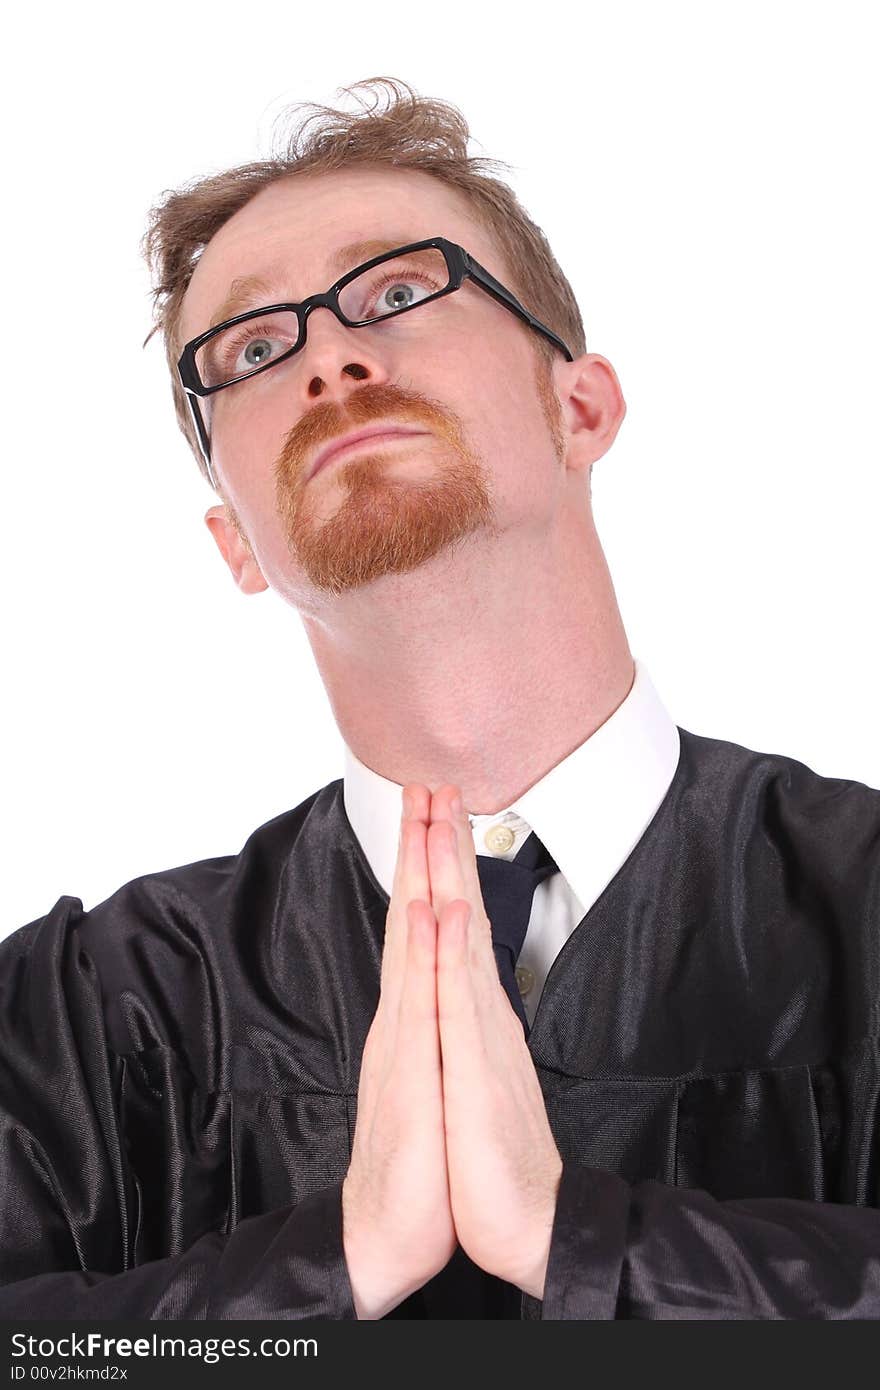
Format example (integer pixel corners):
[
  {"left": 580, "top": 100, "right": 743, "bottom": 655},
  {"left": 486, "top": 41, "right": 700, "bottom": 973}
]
[{"left": 303, "top": 507, "right": 634, "bottom": 815}]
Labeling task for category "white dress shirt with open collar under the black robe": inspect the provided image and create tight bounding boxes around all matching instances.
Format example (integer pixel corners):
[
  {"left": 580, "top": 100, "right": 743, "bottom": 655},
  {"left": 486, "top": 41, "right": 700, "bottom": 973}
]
[{"left": 343, "top": 657, "right": 680, "bottom": 1026}]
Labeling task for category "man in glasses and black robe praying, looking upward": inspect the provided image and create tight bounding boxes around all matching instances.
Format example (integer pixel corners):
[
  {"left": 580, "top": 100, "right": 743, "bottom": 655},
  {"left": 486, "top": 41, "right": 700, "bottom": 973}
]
[{"left": 0, "top": 85, "right": 880, "bottom": 1318}]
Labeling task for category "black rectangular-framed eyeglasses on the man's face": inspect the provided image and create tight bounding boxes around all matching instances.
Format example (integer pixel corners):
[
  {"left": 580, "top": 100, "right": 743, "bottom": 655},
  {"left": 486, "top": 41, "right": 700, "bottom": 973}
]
[{"left": 178, "top": 236, "right": 574, "bottom": 491}]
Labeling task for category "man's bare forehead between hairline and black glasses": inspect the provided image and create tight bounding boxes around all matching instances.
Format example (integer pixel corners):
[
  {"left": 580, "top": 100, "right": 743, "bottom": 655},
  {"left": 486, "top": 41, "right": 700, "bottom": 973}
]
[{"left": 179, "top": 168, "right": 494, "bottom": 342}]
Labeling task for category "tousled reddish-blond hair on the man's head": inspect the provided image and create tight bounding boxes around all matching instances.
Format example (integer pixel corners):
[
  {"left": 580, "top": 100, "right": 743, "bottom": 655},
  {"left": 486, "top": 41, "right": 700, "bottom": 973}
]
[{"left": 142, "top": 78, "right": 587, "bottom": 489}]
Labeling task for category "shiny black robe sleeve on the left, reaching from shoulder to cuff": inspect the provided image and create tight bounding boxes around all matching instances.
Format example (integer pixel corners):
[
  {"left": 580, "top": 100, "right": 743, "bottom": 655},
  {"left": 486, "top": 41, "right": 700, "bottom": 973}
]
[{"left": 0, "top": 898, "right": 356, "bottom": 1319}]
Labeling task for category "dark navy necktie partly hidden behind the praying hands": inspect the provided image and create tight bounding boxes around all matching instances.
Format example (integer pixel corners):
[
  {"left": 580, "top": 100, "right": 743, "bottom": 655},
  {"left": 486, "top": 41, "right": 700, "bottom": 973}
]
[{"left": 477, "top": 830, "right": 557, "bottom": 1037}]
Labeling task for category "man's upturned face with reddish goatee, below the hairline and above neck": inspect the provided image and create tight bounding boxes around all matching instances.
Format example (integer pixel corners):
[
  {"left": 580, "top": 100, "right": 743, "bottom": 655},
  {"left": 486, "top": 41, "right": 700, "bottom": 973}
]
[{"left": 181, "top": 168, "right": 564, "bottom": 609}]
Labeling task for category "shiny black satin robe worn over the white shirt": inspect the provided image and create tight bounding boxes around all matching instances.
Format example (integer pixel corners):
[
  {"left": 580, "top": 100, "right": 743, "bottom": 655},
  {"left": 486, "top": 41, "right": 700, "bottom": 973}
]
[{"left": 0, "top": 730, "right": 880, "bottom": 1319}]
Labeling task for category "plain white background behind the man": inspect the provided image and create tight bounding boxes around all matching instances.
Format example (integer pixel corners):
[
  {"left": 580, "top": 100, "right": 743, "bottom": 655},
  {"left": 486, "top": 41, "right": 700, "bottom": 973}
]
[{"left": 0, "top": 0, "right": 880, "bottom": 935}]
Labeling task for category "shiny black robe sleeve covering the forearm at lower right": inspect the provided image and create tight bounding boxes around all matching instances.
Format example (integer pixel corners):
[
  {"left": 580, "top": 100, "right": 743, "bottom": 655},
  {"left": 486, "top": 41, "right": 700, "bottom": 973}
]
[{"left": 541, "top": 1162, "right": 880, "bottom": 1321}]
